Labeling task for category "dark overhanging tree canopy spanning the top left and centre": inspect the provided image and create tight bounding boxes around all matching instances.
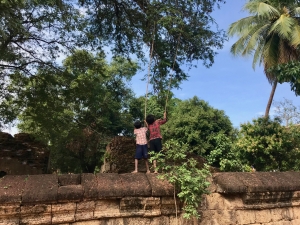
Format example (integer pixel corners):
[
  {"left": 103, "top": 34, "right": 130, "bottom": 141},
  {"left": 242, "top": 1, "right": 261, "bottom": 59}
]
[{"left": 0, "top": 0, "right": 225, "bottom": 130}]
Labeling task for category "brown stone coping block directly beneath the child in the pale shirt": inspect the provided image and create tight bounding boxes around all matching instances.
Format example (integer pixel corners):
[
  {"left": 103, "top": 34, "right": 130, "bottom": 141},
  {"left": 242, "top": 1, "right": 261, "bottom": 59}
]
[{"left": 119, "top": 173, "right": 151, "bottom": 196}]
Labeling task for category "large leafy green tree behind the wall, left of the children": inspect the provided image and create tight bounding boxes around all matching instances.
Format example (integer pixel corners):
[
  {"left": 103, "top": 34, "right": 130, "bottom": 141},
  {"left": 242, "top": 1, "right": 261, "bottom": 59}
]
[{"left": 10, "top": 50, "right": 138, "bottom": 173}]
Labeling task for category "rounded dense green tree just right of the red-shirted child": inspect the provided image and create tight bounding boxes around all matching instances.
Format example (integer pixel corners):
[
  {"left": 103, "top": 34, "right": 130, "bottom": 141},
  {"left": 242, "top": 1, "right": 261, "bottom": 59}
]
[{"left": 161, "top": 97, "right": 233, "bottom": 156}]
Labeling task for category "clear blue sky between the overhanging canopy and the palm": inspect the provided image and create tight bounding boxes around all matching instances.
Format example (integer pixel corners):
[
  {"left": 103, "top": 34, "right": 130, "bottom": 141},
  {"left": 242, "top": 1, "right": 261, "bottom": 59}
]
[{"left": 132, "top": 0, "right": 300, "bottom": 127}]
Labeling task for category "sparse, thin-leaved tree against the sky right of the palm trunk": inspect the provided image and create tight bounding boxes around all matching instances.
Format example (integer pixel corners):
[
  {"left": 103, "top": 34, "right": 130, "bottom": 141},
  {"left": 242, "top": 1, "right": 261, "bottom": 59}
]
[{"left": 273, "top": 98, "right": 300, "bottom": 127}]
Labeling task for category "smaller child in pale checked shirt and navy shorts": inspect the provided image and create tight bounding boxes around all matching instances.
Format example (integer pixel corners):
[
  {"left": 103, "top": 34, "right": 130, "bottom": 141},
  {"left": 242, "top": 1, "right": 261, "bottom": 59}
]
[{"left": 131, "top": 121, "right": 150, "bottom": 173}]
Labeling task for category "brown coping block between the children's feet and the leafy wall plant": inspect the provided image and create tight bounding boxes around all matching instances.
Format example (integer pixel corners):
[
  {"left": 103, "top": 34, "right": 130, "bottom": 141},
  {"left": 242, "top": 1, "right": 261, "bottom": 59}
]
[{"left": 146, "top": 174, "right": 174, "bottom": 196}]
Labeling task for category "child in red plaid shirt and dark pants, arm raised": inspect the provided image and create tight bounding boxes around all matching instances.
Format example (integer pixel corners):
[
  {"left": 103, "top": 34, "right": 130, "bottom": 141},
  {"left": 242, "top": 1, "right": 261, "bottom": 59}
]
[{"left": 146, "top": 112, "right": 167, "bottom": 173}]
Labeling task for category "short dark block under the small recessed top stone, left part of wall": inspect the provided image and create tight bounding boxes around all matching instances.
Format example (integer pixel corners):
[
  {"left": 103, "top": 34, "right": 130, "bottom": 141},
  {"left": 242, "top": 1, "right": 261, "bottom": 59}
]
[{"left": 57, "top": 185, "right": 83, "bottom": 202}]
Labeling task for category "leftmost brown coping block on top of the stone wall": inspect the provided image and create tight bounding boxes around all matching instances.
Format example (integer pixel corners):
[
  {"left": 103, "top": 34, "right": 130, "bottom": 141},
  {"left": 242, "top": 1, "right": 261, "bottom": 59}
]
[{"left": 0, "top": 175, "right": 27, "bottom": 204}]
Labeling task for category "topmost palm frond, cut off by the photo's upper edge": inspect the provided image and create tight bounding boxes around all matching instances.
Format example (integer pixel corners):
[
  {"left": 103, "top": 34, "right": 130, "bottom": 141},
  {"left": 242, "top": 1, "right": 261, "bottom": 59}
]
[{"left": 244, "top": 0, "right": 280, "bottom": 19}]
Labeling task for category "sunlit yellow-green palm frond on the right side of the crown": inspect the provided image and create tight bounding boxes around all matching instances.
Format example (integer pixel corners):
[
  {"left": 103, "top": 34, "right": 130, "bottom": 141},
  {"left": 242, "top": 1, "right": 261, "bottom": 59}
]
[{"left": 269, "top": 14, "right": 296, "bottom": 39}]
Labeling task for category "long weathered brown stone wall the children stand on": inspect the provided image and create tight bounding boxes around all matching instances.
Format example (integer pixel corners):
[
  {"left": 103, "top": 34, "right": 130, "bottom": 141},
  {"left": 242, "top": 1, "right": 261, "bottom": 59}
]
[{"left": 0, "top": 172, "right": 300, "bottom": 225}]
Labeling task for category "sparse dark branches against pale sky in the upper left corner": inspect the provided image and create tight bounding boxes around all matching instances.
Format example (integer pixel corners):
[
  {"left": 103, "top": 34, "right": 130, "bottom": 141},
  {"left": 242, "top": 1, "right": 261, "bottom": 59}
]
[{"left": 0, "top": 0, "right": 83, "bottom": 76}]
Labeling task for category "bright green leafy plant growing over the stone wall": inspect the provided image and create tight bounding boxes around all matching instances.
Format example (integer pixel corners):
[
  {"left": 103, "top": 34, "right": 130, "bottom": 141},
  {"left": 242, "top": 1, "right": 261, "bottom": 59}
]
[{"left": 150, "top": 140, "right": 210, "bottom": 219}]
